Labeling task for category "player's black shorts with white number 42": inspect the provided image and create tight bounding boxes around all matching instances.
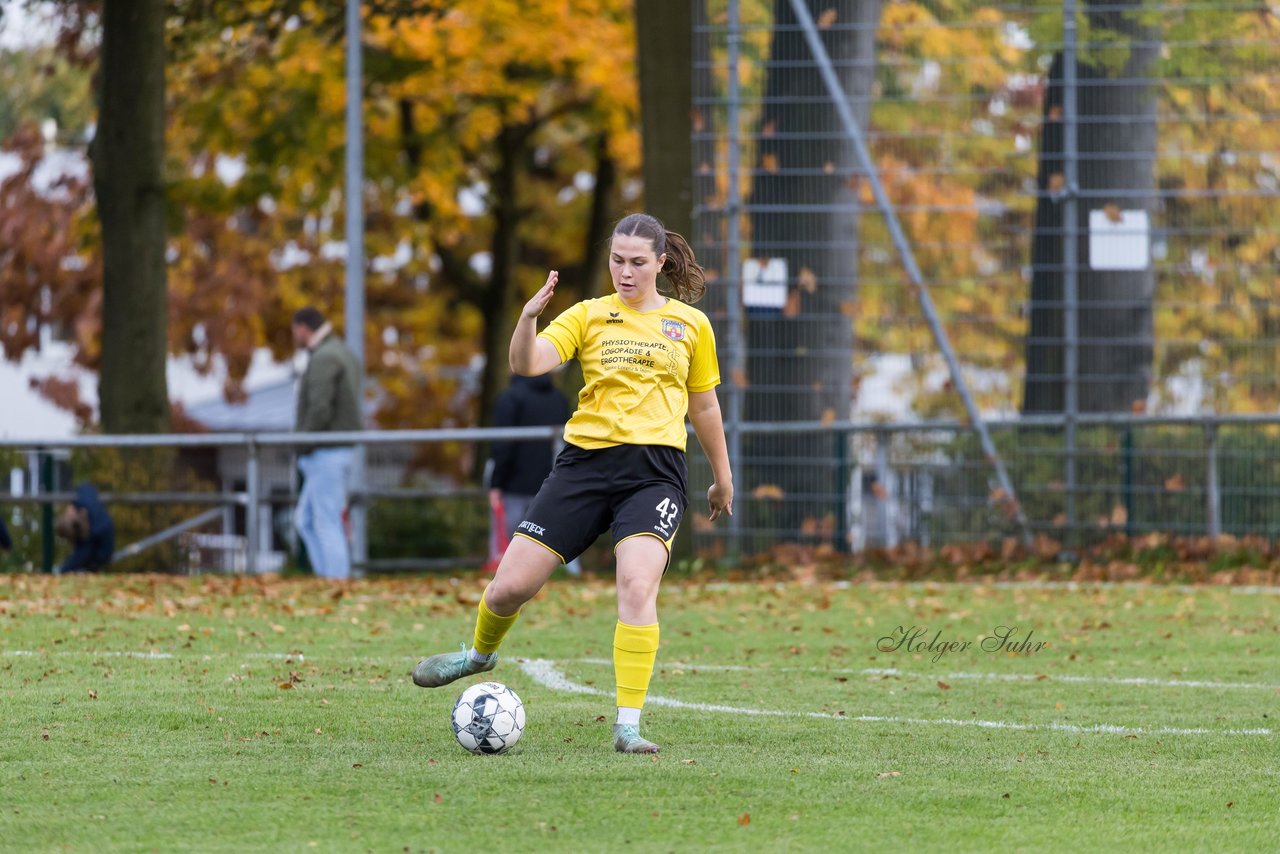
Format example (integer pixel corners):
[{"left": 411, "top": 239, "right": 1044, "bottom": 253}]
[{"left": 516, "top": 444, "right": 689, "bottom": 562}]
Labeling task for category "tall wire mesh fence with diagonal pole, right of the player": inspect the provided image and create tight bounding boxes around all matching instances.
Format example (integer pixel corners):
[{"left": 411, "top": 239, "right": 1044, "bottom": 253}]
[{"left": 694, "top": 0, "right": 1280, "bottom": 555}]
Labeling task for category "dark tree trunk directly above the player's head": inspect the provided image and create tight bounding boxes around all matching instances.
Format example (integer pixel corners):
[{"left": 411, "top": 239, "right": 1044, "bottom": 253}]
[{"left": 635, "top": 0, "right": 694, "bottom": 237}]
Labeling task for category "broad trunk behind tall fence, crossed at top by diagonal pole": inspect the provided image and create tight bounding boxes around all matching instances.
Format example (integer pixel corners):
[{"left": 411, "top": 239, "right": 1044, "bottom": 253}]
[{"left": 741, "top": 0, "right": 879, "bottom": 540}]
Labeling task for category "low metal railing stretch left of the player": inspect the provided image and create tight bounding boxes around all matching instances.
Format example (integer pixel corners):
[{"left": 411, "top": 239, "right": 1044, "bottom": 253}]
[{"left": 0, "top": 428, "right": 559, "bottom": 574}]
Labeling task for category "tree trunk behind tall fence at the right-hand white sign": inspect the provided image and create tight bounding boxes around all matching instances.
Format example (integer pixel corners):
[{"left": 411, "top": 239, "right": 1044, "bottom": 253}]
[{"left": 1023, "top": 0, "right": 1158, "bottom": 412}]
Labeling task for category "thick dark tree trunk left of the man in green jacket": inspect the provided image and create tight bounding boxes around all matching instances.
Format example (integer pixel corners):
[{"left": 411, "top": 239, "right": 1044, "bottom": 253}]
[{"left": 90, "top": 0, "right": 170, "bottom": 433}]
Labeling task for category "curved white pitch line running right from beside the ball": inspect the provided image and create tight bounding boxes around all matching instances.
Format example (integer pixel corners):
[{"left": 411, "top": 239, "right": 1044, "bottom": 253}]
[{"left": 520, "top": 658, "right": 1275, "bottom": 736}]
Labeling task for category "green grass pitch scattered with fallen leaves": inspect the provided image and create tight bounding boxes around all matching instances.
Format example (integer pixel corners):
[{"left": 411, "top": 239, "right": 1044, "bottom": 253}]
[{"left": 0, "top": 575, "right": 1280, "bottom": 851}]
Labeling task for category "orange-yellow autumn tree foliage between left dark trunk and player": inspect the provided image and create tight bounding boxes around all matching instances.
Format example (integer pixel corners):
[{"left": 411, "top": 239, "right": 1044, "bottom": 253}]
[{"left": 8, "top": 0, "right": 639, "bottom": 460}]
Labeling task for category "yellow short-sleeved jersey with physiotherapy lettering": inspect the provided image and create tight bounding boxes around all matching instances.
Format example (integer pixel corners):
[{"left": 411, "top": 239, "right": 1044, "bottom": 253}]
[{"left": 539, "top": 293, "right": 719, "bottom": 451}]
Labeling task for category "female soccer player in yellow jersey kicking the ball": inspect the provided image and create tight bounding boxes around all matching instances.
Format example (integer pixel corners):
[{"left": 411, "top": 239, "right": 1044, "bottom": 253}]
[{"left": 413, "top": 214, "right": 733, "bottom": 753}]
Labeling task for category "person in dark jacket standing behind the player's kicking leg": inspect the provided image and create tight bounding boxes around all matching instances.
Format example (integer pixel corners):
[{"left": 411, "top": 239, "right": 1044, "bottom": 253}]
[{"left": 489, "top": 374, "right": 577, "bottom": 575}]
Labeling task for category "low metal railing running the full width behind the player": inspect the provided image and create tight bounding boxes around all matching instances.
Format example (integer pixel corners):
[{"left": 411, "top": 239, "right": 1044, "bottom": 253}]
[{"left": 10, "top": 414, "right": 1280, "bottom": 574}]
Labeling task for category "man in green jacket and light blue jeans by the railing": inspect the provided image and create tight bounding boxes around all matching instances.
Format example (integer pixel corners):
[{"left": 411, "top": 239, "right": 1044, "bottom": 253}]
[{"left": 293, "top": 306, "right": 362, "bottom": 579}]
